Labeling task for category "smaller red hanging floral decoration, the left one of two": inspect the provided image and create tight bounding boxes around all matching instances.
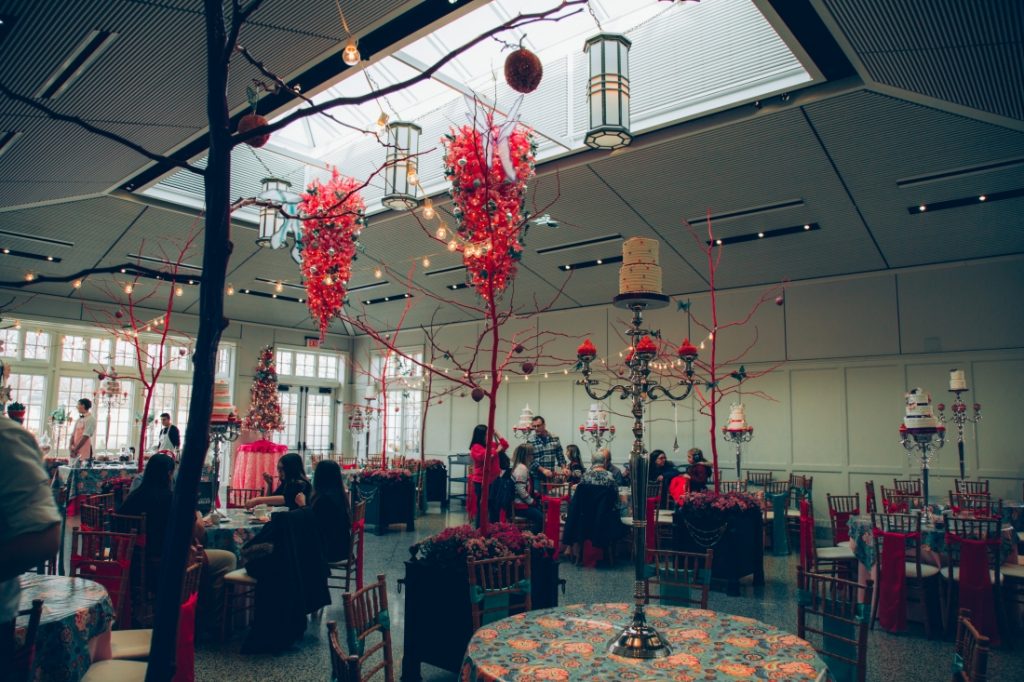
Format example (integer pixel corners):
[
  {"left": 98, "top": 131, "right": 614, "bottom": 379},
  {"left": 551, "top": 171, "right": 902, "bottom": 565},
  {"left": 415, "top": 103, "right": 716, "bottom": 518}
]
[{"left": 299, "top": 169, "right": 367, "bottom": 340}]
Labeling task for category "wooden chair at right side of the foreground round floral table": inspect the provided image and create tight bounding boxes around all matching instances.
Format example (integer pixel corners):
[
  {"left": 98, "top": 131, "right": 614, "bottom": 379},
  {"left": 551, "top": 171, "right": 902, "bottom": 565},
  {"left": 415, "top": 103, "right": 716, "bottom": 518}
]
[{"left": 797, "top": 567, "right": 874, "bottom": 682}]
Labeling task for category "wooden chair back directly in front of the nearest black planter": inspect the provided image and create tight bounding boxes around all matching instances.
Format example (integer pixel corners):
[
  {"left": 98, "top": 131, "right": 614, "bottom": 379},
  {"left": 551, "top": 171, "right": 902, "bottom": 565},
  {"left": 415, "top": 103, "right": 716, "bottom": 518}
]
[{"left": 466, "top": 551, "right": 532, "bottom": 631}]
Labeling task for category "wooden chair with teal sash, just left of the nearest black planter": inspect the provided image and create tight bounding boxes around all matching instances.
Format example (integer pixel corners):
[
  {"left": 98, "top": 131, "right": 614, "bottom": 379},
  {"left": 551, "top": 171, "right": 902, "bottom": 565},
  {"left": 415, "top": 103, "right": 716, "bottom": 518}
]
[{"left": 344, "top": 574, "right": 394, "bottom": 682}]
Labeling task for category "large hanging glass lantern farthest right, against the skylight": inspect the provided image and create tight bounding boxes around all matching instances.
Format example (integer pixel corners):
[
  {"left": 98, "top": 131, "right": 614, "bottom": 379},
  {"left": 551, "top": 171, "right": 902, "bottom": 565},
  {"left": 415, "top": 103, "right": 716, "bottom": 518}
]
[{"left": 584, "top": 33, "right": 633, "bottom": 150}]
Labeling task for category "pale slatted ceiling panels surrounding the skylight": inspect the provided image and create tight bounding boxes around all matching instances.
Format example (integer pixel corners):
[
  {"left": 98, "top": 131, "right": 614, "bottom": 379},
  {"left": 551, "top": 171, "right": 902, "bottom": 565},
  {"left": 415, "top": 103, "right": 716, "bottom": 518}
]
[{"left": 0, "top": 0, "right": 1024, "bottom": 332}]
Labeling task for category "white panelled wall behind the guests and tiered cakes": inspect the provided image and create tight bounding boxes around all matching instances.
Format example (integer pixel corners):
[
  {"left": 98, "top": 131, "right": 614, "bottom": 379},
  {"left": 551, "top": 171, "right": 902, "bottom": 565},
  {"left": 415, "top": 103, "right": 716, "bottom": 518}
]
[{"left": 353, "top": 257, "right": 1024, "bottom": 500}]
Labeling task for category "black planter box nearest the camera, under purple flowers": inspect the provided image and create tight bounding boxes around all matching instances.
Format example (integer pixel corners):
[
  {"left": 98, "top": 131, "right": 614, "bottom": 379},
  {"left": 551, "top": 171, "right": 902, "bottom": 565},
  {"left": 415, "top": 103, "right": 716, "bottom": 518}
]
[{"left": 401, "top": 557, "right": 559, "bottom": 682}]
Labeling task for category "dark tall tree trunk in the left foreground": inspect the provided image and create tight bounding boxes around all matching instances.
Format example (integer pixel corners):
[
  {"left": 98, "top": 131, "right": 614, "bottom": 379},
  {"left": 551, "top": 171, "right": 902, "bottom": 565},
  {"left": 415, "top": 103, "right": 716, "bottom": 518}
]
[{"left": 145, "top": 0, "right": 231, "bottom": 682}]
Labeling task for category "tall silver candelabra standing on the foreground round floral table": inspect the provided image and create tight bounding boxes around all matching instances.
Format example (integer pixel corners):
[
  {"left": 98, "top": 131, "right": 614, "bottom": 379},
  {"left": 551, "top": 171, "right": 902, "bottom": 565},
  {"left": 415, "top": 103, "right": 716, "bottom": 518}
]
[{"left": 577, "top": 294, "right": 697, "bottom": 658}]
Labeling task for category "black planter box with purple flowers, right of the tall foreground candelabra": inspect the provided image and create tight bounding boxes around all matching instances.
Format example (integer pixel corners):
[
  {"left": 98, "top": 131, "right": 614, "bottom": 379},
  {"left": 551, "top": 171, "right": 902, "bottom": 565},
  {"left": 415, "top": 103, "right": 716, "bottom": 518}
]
[{"left": 672, "top": 501, "right": 765, "bottom": 596}]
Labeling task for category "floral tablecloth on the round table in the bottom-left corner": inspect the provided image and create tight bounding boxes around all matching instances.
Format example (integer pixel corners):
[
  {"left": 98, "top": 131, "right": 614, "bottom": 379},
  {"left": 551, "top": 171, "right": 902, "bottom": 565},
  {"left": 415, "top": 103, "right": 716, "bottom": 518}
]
[{"left": 16, "top": 573, "right": 114, "bottom": 682}]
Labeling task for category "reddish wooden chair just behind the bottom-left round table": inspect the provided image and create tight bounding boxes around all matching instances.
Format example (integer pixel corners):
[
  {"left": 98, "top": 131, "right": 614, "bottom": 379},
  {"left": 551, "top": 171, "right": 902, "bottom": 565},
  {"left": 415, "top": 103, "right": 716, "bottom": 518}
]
[{"left": 70, "top": 527, "right": 135, "bottom": 627}]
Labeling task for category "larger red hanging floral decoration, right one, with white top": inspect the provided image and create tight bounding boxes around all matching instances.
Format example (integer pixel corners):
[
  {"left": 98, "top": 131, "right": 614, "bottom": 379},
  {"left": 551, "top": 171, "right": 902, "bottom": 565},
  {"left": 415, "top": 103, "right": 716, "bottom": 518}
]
[{"left": 442, "top": 103, "right": 536, "bottom": 300}]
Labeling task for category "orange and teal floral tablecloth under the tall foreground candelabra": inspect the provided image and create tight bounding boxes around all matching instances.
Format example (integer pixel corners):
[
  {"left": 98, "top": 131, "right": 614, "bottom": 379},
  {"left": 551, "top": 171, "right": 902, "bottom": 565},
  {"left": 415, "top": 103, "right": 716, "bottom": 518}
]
[{"left": 460, "top": 604, "right": 825, "bottom": 682}]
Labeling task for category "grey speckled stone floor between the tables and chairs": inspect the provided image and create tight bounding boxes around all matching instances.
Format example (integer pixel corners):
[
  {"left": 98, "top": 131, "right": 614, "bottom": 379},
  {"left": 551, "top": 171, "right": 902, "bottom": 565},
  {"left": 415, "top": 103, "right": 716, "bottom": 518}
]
[{"left": 196, "top": 505, "right": 1024, "bottom": 682}]
